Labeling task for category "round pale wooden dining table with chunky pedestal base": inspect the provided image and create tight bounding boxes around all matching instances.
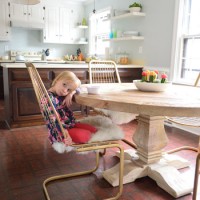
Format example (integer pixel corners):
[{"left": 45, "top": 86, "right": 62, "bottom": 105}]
[{"left": 75, "top": 83, "right": 200, "bottom": 198}]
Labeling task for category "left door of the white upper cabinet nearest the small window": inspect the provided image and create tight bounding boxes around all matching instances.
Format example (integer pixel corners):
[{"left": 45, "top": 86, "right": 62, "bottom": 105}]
[{"left": 43, "top": 6, "right": 60, "bottom": 43}]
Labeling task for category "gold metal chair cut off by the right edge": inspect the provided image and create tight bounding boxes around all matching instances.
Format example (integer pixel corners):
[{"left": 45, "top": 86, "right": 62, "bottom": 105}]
[{"left": 166, "top": 73, "right": 200, "bottom": 200}]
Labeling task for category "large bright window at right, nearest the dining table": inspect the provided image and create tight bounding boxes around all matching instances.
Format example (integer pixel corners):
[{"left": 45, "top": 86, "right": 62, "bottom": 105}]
[{"left": 174, "top": 0, "right": 200, "bottom": 84}]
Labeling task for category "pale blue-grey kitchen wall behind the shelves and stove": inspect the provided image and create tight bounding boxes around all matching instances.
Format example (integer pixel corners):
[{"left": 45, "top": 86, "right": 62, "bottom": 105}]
[{"left": 0, "top": 0, "right": 176, "bottom": 74}]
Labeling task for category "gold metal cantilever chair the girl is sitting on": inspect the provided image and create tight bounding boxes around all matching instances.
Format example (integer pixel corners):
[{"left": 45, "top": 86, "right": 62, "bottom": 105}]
[{"left": 26, "top": 63, "right": 124, "bottom": 200}]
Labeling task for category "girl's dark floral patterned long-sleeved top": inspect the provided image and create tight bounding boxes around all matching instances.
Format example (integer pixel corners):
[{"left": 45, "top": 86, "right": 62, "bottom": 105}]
[{"left": 41, "top": 92, "right": 76, "bottom": 144}]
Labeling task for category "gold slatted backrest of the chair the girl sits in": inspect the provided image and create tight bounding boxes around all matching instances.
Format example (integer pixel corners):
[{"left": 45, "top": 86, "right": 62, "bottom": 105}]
[{"left": 25, "top": 63, "right": 68, "bottom": 142}]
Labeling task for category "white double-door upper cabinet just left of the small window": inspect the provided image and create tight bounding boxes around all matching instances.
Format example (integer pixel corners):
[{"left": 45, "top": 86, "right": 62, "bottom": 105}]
[{"left": 43, "top": 4, "right": 84, "bottom": 44}]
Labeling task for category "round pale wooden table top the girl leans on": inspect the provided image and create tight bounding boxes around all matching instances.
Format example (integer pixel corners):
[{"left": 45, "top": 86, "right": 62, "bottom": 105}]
[{"left": 75, "top": 83, "right": 200, "bottom": 117}]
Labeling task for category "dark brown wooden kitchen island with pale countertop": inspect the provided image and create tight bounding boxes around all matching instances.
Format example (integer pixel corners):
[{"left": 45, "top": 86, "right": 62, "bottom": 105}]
[{"left": 1, "top": 63, "right": 142, "bottom": 128}]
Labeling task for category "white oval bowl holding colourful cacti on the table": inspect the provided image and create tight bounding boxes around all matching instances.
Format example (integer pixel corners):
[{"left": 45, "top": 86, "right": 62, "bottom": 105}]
[{"left": 133, "top": 80, "right": 171, "bottom": 92}]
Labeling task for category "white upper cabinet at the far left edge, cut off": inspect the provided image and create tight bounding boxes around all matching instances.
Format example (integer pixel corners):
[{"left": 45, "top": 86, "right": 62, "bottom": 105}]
[{"left": 0, "top": 0, "right": 10, "bottom": 41}]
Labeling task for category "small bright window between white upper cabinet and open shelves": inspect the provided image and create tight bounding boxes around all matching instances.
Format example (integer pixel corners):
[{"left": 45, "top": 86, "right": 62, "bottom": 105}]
[{"left": 89, "top": 8, "right": 111, "bottom": 56}]
